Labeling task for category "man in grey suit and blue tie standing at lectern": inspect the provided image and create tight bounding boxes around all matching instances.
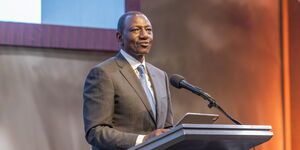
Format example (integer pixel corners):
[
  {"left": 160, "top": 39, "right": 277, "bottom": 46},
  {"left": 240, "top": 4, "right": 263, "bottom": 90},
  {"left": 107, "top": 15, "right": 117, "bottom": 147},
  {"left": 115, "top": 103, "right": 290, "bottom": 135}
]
[{"left": 83, "top": 11, "right": 173, "bottom": 150}]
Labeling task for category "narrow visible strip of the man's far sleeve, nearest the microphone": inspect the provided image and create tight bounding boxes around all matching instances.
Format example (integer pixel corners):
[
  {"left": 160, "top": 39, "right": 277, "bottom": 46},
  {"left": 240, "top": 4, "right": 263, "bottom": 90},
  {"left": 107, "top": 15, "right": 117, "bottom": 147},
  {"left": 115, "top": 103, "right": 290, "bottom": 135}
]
[{"left": 164, "top": 73, "right": 173, "bottom": 128}]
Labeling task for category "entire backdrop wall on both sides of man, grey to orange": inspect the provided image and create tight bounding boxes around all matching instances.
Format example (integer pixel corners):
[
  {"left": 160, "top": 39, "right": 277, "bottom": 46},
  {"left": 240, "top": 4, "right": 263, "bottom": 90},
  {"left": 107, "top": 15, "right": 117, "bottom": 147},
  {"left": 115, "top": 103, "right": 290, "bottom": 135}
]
[{"left": 0, "top": 0, "right": 292, "bottom": 150}]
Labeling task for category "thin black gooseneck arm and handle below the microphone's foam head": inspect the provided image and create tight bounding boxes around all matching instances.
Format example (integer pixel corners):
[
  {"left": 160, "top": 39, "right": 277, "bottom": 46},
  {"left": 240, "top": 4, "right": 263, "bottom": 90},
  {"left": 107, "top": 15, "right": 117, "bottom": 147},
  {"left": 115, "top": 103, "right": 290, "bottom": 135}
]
[{"left": 181, "top": 82, "right": 242, "bottom": 125}]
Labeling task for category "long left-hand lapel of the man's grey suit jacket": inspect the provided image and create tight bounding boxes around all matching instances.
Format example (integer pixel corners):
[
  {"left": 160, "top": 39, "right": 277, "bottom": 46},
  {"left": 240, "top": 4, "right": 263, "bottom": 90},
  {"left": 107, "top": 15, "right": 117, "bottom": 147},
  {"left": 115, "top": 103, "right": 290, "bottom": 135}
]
[{"left": 116, "top": 53, "right": 156, "bottom": 124}]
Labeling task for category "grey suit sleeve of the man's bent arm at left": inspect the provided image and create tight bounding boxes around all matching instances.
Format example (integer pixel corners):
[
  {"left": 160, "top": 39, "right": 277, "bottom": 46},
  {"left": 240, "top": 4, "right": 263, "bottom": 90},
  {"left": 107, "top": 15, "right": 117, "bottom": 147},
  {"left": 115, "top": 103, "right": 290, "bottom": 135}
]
[{"left": 83, "top": 67, "right": 138, "bottom": 149}]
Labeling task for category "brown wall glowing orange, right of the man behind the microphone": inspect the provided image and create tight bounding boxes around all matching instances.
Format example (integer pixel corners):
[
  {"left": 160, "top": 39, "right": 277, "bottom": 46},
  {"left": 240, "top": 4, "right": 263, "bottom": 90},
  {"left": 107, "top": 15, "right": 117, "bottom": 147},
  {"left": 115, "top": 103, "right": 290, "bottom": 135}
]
[{"left": 142, "top": 0, "right": 283, "bottom": 149}]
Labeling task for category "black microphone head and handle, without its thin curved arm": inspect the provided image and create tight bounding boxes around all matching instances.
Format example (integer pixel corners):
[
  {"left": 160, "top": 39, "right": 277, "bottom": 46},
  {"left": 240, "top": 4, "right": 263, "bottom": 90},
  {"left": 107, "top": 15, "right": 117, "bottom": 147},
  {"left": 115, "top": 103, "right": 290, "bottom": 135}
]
[{"left": 170, "top": 74, "right": 212, "bottom": 100}]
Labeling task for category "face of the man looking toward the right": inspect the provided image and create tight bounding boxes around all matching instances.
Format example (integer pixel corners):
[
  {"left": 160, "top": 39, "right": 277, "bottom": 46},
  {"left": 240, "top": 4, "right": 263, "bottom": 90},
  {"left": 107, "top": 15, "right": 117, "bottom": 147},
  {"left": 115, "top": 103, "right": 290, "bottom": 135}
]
[{"left": 118, "top": 14, "right": 153, "bottom": 60}]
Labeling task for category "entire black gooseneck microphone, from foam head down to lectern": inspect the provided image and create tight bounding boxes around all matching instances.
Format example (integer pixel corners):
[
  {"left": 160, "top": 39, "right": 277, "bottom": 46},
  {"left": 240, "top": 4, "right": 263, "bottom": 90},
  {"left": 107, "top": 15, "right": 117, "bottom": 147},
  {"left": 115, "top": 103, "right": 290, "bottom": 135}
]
[{"left": 170, "top": 74, "right": 241, "bottom": 125}]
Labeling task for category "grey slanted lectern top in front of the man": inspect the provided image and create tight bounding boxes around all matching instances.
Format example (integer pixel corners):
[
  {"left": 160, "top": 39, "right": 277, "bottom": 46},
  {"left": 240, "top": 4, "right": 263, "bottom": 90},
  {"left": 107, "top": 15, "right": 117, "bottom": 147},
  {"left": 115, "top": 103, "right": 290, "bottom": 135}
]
[{"left": 129, "top": 124, "right": 273, "bottom": 150}]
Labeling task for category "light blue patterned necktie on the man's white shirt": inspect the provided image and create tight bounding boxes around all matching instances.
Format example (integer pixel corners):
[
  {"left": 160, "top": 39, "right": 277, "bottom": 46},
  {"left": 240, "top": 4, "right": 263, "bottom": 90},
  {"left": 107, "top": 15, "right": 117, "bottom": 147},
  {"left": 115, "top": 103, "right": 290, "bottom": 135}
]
[{"left": 137, "top": 65, "right": 156, "bottom": 119}]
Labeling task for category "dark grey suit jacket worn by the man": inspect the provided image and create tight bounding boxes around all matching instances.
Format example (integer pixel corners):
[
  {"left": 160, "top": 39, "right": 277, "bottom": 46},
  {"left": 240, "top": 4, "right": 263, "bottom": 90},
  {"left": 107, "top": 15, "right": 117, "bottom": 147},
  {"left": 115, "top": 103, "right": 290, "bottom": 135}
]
[{"left": 83, "top": 53, "right": 173, "bottom": 150}]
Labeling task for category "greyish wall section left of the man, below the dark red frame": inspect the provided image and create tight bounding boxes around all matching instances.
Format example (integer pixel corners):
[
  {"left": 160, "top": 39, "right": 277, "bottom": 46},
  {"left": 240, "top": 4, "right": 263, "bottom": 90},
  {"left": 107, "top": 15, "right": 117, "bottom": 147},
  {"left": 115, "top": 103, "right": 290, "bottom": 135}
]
[{"left": 0, "top": 46, "right": 114, "bottom": 150}]
